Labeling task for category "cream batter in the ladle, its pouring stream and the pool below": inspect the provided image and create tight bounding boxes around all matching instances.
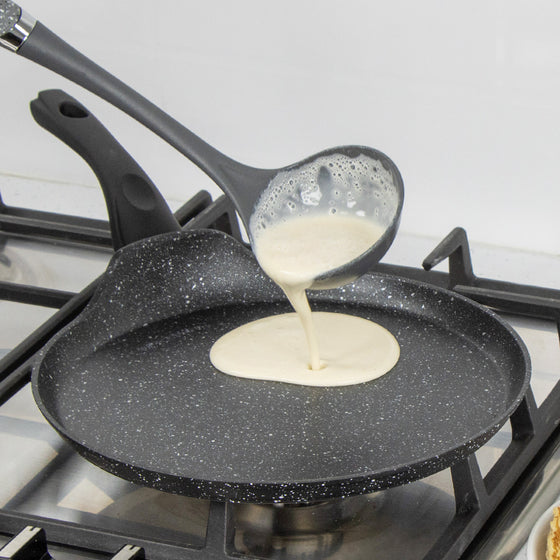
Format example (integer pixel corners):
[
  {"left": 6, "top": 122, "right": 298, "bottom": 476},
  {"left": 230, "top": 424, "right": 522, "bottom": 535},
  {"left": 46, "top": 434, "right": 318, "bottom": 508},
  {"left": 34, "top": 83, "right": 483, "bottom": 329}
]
[{"left": 210, "top": 214, "right": 399, "bottom": 386}]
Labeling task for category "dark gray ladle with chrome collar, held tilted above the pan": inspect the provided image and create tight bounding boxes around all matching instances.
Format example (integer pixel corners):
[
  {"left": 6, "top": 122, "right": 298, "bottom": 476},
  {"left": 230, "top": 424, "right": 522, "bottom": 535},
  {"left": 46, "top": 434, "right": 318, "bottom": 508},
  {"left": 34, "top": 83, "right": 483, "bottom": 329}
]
[{"left": 0, "top": 0, "right": 404, "bottom": 288}]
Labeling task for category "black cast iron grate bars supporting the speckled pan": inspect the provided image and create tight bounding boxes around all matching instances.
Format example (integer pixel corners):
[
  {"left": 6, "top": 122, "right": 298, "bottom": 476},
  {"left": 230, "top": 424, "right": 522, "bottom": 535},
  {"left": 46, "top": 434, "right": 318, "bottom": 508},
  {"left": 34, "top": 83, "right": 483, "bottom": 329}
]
[{"left": 0, "top": 193, "right": 560, "bottom": 560}]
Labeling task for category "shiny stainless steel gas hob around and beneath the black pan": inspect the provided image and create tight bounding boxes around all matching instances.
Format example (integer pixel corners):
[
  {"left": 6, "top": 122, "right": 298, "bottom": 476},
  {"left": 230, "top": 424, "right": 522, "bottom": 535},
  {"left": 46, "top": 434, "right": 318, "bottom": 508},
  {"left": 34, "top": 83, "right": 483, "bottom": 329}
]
[{"left": 0, "top": 190, "right": 560, "bottom": 560}]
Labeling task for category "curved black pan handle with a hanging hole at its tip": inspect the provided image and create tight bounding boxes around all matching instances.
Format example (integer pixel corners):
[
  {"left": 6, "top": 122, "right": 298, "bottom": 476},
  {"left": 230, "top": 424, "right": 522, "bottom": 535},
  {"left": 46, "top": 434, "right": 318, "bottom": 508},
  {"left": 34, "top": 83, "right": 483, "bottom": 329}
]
[{"left": 30, "top": 90, "right": 181, "bottom": 249}]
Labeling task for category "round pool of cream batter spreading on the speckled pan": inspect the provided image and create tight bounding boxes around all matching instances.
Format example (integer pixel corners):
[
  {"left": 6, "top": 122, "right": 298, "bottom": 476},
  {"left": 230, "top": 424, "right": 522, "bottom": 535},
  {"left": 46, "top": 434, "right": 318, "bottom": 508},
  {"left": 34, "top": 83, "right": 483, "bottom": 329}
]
[{"left": 210, "top": 311, "right": 399, "bottom": 387}]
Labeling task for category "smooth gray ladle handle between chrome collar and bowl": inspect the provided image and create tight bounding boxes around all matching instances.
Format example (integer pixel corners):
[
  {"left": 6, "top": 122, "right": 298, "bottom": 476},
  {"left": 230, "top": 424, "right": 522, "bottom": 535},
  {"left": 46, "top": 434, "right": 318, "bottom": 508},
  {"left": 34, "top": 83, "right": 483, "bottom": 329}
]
[{"left": 17, "top": 21, "right": 258, "bottom": 221}]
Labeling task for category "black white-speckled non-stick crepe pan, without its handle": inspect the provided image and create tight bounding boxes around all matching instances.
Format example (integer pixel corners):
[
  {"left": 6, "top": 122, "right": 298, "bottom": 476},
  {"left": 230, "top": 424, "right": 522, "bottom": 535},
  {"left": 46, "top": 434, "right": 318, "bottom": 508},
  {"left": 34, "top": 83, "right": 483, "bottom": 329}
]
[{"left": 33, "top": 230, "right": 530, "bottom": 502}]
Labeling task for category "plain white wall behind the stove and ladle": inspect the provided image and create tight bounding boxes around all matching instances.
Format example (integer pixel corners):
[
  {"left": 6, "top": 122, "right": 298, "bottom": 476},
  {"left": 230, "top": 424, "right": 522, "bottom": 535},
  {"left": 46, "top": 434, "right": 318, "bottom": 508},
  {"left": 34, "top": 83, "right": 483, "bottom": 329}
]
[{"left": 0, "top": 0, "right": 560, "bottom": 254}]
